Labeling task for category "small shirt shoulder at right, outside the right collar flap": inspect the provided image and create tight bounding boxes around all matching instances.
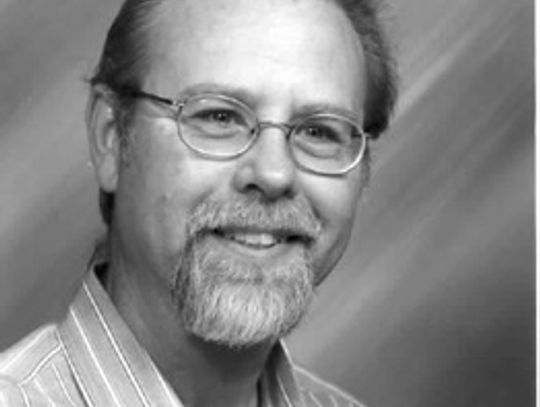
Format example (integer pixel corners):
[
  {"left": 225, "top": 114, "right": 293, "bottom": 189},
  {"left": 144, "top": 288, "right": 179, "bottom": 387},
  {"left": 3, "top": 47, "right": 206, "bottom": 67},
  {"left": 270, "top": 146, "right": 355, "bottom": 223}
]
[{"left": 293, "top": 365, "right": 366, "bottom": 407}]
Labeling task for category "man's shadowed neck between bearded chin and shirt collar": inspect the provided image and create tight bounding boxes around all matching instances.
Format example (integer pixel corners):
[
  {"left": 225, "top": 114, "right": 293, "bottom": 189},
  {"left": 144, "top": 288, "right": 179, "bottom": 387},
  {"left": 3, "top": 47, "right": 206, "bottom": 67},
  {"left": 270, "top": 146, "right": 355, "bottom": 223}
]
[{"left": 106, "top": 244, "right": 273, "bottom": 407}]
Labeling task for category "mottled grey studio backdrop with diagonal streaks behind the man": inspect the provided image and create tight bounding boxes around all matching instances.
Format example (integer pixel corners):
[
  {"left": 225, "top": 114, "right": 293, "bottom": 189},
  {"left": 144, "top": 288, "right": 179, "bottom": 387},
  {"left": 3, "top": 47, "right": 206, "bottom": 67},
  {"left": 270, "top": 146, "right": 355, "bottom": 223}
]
[{"left": 0, "top": 0, "right": 535, "bottom": 407}]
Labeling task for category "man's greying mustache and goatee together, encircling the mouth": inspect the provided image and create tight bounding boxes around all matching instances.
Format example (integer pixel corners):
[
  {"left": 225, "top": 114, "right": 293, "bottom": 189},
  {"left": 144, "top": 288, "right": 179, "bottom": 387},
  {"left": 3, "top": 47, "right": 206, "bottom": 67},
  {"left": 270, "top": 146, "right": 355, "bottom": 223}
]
[{"left": 173, "top": 195, "right": 321, "bottom": 347}]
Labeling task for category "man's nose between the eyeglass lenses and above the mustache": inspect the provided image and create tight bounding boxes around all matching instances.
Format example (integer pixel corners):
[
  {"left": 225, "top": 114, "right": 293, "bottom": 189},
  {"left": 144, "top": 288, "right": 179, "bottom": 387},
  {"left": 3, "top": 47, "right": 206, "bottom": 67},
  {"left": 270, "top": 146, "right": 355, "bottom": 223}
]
[{"left": 234, "top": 125, "right": 296, "bottom": 200}]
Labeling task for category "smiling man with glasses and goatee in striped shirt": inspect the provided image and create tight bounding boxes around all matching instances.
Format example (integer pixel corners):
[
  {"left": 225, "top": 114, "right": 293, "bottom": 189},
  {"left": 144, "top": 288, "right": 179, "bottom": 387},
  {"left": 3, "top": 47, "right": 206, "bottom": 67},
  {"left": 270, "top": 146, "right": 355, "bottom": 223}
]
[{"left": 0, "top": 0, "right": 395, "bottom": 407}]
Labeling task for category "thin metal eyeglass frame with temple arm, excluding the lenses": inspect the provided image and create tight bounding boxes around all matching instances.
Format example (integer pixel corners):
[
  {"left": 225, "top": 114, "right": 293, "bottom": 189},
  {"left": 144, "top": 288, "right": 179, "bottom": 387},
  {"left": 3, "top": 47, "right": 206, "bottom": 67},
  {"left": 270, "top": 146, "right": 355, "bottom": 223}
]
[{"left": 112, "top": 86, "right": 370, "bottom": 176}]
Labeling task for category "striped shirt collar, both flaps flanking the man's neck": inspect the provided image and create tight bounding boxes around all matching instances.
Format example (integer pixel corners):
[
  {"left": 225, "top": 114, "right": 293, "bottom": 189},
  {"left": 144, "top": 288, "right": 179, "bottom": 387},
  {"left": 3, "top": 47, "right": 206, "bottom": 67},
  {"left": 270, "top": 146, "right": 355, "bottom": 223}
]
[{"left": 59, "top": 267, "right": 303, "bottom": 407}]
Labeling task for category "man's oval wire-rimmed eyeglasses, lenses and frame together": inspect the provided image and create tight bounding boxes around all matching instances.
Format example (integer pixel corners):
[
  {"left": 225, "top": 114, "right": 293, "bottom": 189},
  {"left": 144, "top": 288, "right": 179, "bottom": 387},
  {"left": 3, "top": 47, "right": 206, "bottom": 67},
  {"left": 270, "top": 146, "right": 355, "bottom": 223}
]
[{"left": 119, "top": 88, "right": 367, "bottom": 175}]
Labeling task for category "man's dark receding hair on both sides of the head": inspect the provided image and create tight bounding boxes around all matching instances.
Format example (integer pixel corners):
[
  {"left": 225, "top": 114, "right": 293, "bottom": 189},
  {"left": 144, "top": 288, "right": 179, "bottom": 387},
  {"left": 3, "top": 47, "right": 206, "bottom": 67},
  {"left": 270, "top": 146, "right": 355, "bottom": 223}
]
[{"left": 89, "top": 0, "right": 397, "bottom": 226}]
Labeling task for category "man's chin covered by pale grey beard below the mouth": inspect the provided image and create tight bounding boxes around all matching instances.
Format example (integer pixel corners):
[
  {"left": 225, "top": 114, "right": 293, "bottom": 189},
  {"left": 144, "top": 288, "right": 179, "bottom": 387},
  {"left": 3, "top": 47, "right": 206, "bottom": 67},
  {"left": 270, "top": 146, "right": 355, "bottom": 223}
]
[{"left": 174, "top": 237, "right": 314, "bottom": 348}]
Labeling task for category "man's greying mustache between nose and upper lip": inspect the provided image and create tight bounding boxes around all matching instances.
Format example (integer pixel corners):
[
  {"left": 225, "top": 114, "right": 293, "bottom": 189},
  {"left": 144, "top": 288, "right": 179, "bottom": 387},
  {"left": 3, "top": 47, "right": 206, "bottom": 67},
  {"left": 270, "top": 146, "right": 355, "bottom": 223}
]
[{"left": 186, "top": 195, "right": 322, "bottom": 241}]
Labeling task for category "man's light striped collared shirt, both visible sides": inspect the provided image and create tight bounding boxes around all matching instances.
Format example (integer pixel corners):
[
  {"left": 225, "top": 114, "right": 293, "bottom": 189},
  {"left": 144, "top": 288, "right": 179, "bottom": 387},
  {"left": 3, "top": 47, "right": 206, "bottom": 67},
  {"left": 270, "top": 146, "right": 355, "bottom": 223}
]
[{"left": 0, "top": 270, "right": 361, "bottom": 407}]
